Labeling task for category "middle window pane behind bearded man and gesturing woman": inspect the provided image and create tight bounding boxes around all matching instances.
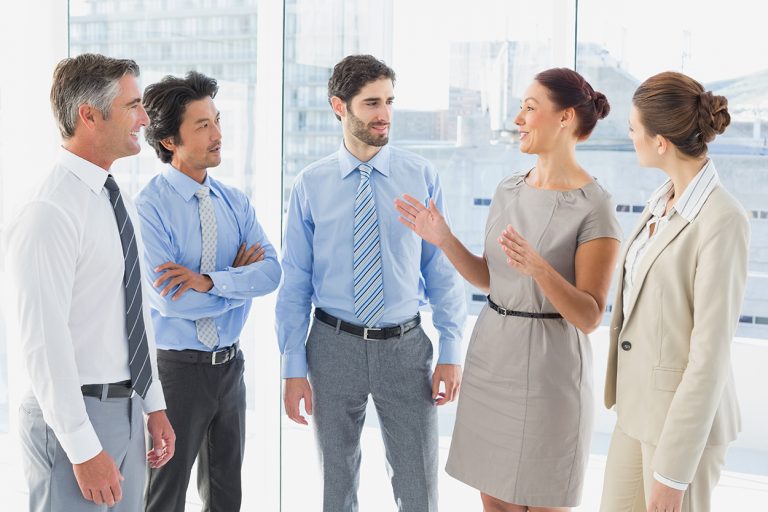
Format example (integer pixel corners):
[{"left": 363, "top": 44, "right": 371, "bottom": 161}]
[{"left": 281, "top": 0, "right": 574, "bottom": 511}]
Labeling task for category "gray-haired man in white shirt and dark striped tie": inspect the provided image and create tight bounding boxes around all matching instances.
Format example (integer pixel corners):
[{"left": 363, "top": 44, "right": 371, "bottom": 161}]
[{"left": 8, "top": 55, "right": 175, "bottom": 512}]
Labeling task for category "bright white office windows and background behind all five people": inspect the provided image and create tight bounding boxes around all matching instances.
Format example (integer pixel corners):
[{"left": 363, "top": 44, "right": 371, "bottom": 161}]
[{"left": 0, "top": 0, "right": 768, "bottom": 512}]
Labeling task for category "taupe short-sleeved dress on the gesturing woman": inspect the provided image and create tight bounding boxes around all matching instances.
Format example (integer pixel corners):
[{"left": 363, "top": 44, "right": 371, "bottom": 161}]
[{"left": 446, "top": 174, "right": 621, "bottom": 507}]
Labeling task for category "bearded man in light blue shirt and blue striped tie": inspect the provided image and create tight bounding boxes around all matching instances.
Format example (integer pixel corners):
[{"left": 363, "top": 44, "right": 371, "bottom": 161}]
[{"left": 276, "top": 55, "right": 466, "bottom": 512}]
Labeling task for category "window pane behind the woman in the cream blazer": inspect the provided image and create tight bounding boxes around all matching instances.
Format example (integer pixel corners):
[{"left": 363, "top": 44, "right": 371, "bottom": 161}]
[{"left": 577, "top": 0, "right": 768, "bottom": 510}]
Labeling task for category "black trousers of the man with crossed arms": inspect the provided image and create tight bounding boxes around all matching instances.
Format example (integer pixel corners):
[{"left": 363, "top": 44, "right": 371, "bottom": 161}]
[{"left": 145, "top": 350, "right": 245, "bottom": 512}]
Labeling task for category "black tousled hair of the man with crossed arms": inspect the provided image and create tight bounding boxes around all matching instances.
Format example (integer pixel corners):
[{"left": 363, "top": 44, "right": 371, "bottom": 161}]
[{"left": 144, "top": 71, "right": 219, "bottom": 163}]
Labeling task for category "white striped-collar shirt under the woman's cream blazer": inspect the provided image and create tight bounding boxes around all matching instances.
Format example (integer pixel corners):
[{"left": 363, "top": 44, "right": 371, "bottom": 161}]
[{"left": 622, "top": 160, "right": 720, "bottom": 491}]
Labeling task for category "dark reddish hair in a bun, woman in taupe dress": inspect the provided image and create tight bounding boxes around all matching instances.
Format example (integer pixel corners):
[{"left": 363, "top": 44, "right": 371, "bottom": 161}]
[{"left": 534, "top": 68, "right": 611, "bottom": 138}]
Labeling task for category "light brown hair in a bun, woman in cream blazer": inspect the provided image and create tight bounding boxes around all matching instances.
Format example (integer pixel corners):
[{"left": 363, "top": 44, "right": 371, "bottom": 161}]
[{"left": 632, "top": 71, "right": 731, "bottom": 157}]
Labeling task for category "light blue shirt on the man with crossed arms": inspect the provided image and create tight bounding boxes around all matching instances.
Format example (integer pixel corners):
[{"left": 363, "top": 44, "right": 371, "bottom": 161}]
[{"left": 136, "top": 165, "right": 281, "bottom": 351}]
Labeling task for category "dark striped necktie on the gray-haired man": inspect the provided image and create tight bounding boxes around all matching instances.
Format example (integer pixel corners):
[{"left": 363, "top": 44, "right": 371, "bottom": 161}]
[{"left": 104, "top": 174, "right": 152, "bottom": 398}]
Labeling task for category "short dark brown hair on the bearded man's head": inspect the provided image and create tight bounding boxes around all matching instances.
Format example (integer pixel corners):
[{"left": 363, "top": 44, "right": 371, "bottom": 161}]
[{"left": 328, "top": 55, "right": 395, "bottom": 120}]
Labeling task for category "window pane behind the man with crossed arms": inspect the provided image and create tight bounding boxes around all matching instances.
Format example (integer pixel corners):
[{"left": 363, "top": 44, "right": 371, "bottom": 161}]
[{"left": 63, "top": 0, "right": 282, "bottom": 511}]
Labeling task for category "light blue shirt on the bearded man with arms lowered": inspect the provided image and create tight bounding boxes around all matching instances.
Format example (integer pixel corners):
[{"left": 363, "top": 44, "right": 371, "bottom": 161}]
[{"left": 276, "top": 143, "right": 466, "bottom": 378}]
